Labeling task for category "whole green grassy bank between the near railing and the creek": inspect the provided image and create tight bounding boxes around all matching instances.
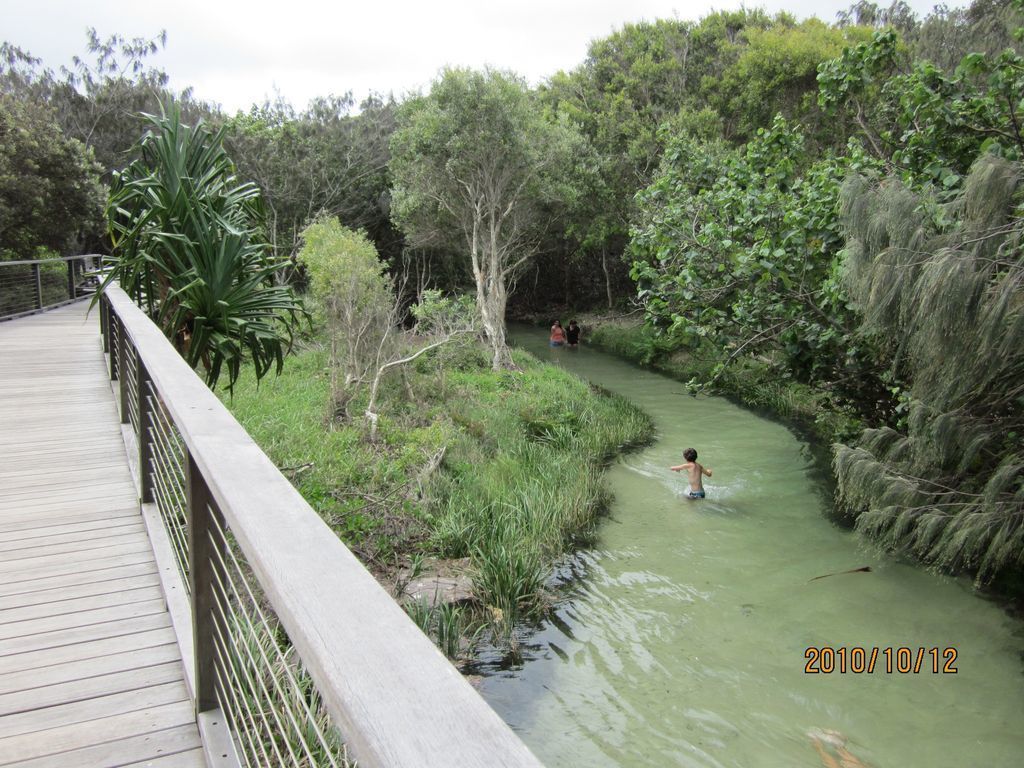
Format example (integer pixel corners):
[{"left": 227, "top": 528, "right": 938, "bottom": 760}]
[{"left": 224, "top": 344, "right": 651, "bottom": 646}]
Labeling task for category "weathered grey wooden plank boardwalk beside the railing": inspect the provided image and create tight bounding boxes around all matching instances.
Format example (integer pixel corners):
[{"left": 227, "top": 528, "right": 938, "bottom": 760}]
[{"left": 0, "top": 303, "right": 206, "bottom": 768}]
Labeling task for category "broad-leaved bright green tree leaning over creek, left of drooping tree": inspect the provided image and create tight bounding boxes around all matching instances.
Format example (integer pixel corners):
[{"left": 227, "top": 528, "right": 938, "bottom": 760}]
[{"left": 630, "top": 118, "right": 871, "bottom": 393}]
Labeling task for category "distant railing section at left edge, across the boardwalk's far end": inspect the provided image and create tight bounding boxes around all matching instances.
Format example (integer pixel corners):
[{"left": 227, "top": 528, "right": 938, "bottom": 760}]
[{"left": 0, "top": 254, "right": 102, "bottom": 321}]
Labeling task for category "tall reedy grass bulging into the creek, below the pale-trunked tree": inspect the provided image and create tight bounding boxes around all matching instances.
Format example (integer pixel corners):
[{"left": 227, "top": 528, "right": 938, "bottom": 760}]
[{"left": 421, "top": 351, "right": 651, "bottom": 627}]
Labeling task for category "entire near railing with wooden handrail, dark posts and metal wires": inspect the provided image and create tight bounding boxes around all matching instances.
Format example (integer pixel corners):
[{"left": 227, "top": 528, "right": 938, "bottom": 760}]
[{"left": 99, "top": 286, "right": 540, "bottom": 768}]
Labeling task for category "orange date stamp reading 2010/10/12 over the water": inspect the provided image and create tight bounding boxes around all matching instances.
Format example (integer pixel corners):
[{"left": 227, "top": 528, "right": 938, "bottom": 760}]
[{"left": 804, "top": 645, "right": 956, "bottom": 675}]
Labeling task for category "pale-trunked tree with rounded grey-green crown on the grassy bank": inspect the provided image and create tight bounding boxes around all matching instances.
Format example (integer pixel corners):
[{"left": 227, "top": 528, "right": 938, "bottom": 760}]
[{"left": 390, "top": 70, "right": 581, "bottom": 370}]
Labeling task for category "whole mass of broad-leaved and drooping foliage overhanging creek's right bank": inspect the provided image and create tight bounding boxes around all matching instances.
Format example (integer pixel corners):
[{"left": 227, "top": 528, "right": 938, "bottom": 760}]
[{"left": 630, "top": 3, "right": 1024, "bottom": 579}]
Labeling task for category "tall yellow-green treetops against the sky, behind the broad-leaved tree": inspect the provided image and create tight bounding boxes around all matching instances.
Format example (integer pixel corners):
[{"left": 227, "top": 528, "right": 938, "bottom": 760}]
[{"left": 542, "top": 10, "right": 867, "bottom": 307}]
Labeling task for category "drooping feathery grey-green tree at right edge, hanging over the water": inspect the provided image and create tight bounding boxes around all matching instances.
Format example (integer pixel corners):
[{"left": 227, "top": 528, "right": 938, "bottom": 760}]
[{"left": 835, "top": 155, "right": 1024, "bottom": 581}]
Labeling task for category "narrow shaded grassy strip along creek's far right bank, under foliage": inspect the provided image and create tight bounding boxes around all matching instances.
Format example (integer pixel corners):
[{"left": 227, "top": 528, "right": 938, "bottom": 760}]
[{"left": 585, "top": 316, "right": 862, "bottom": 445}]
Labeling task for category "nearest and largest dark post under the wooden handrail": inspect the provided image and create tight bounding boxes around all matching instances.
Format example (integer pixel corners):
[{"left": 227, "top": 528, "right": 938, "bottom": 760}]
[{"left": 185, "top": 452, "right": 218, "bottom": 713}]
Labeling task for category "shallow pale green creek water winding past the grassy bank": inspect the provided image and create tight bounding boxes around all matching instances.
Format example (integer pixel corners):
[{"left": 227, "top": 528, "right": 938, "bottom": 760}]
[{"left": 480, "top": 328, "right": 1024, "bottom": 768}]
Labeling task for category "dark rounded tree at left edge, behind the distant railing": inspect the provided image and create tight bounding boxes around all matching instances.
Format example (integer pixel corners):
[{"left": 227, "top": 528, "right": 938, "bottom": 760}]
[{"left": 0, "top": 93, "right": 102, "bottom": 259}]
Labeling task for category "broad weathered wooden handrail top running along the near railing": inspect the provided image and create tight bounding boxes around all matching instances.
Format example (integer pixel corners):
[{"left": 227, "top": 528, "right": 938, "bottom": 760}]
[{"left": 104, "top": 286, "right": 540, "bottom": 768}]
